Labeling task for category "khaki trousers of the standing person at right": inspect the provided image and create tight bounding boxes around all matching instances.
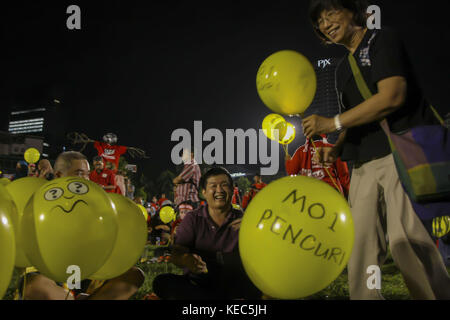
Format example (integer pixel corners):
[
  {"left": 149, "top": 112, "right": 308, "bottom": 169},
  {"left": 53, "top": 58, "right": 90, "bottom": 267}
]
[{"left": 348, "top": 155, "right": 450, "bottom": 300}]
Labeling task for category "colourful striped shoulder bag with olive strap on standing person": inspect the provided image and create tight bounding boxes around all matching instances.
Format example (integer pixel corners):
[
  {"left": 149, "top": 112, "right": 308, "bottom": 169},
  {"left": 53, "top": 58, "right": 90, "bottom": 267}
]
[{"left": 348, "top": 54, "right": 450, "bottom": 218}]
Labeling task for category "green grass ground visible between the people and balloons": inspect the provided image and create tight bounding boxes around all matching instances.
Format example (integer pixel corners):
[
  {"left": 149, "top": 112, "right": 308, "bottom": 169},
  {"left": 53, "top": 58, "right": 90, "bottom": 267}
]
[{"left": 3, "top": 246, "right": 450, "bottom": 300}]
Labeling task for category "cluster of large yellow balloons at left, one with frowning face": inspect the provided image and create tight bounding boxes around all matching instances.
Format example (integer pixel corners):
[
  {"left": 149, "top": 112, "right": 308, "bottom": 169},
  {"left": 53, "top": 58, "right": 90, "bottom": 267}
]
[{"left": 0, "top": 177, "right": 147, "bottom": 286}]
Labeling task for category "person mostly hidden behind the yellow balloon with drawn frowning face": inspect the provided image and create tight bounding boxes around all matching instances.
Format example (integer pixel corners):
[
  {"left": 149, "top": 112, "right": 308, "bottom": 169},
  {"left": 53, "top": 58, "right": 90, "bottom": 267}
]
[{"left": 19, "top": 151, "right": 146, "bottom": 300}]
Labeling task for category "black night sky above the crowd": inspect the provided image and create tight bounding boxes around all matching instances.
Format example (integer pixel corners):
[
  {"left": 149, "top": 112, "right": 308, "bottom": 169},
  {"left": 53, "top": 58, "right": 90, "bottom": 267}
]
[{"left": 0, "top": 0, "right": 450, "bottom": 179}]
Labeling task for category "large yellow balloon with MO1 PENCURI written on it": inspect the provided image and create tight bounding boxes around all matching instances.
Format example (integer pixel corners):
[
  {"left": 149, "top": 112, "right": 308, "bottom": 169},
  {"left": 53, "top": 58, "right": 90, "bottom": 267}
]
[{"left": 239, "top": 176, "right": 354, "bottom": 299}]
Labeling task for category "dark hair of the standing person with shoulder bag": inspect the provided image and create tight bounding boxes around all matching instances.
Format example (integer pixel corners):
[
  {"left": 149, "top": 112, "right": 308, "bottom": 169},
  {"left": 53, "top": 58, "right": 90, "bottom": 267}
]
[{"left": 308, "top": 0, "right": 368, "bottom": 44}]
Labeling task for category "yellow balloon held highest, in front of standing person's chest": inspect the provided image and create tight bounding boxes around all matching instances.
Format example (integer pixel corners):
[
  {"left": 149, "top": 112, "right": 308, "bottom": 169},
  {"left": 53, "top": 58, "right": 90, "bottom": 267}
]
[{"left": 256, "top": 50, "right": 317, "bottom": 115}]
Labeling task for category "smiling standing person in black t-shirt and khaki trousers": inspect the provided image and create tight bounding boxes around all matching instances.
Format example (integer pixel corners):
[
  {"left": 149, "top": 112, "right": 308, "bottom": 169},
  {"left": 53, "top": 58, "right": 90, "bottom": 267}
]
[{"left": 302, "top": 0, "right": 450, "bottom": 299}]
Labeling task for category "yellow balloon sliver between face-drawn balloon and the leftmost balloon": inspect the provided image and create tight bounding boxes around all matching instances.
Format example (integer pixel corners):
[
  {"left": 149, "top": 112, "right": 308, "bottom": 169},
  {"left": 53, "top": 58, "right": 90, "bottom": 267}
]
[{"left": 6, "top": 177, "right": 47, "bottom": 268}]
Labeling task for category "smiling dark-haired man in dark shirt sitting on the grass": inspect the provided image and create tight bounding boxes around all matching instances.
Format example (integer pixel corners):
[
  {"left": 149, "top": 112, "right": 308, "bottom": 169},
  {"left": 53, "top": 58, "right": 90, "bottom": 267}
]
[{"left": 153, "top": 167, "right": 261, "bottom": 300}]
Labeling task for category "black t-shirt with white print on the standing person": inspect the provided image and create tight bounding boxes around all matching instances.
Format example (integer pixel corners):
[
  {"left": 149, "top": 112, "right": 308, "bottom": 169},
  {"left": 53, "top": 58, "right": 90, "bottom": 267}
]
[{"left": 336, "top": 28, "right": 436, "bottom": 162}]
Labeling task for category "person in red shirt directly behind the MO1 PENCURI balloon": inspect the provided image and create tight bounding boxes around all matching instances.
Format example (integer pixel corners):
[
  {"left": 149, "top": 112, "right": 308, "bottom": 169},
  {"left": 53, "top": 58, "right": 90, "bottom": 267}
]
[{"left": 286, "top": 135, "right": 350, "bottom": 198}]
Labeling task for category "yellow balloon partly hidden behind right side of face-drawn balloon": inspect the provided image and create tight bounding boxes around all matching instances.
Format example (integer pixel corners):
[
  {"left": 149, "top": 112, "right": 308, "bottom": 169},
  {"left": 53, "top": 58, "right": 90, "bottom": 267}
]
[{"left": 90, "top": 193, "right": 147, "bottom": 280}]
